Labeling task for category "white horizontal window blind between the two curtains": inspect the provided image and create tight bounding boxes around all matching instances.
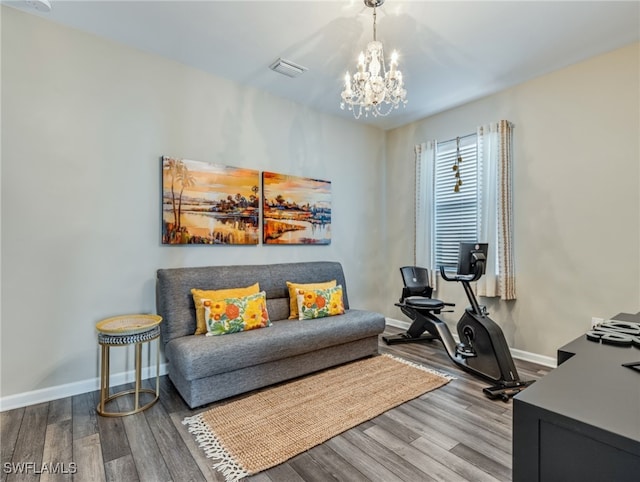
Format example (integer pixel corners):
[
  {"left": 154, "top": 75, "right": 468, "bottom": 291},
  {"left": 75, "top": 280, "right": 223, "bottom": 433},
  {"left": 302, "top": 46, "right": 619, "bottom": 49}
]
[{"left": 434, "top": 134, "right": 482, "bottom": 269}]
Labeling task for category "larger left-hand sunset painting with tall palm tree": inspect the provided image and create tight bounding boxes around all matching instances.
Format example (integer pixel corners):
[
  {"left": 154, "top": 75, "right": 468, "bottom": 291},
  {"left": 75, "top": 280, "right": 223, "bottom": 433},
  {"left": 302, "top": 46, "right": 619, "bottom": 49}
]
[{"left": 162, "top": 156, "right": 260, "bottom": 244}]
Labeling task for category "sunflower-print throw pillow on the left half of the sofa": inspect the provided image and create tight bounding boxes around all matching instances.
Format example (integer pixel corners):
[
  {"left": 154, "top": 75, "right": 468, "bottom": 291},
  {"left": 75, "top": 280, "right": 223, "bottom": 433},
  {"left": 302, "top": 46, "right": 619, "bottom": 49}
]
[{"left": 203, "top": 291, "right": 271, "bottom": 336}]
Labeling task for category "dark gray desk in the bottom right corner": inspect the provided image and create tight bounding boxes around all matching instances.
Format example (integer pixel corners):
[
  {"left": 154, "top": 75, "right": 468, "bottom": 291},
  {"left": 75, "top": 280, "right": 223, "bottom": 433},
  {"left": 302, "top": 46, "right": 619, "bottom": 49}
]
[{"left": 513, "top": 313, "right": 640, "bottom": 482}]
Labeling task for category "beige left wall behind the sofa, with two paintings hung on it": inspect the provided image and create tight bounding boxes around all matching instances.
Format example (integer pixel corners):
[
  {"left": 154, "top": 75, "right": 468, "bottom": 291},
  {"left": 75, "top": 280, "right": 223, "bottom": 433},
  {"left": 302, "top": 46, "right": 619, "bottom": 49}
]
[{"left": 0, "top": 7, "right": 384, "bottom": 397}]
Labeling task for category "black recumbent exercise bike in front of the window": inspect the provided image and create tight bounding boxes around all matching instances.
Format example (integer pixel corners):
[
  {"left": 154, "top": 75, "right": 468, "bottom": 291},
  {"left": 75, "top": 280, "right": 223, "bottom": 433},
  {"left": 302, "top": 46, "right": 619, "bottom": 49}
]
[{"left": 383, "top": 243, "right": 533, "bottom": 402}]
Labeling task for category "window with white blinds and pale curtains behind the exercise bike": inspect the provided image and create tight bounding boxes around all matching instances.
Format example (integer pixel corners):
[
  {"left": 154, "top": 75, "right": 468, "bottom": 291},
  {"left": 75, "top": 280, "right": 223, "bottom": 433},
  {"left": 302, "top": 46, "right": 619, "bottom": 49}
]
[{"left": 414, "top": 120, "right": 516, "bottom": 300}]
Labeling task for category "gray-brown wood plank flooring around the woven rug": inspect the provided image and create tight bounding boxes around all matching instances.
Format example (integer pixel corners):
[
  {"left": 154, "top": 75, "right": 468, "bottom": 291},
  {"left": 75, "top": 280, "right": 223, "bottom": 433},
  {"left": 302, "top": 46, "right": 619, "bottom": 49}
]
[{"left": 0, "top": 327, "right": 549, "bottom": 482}]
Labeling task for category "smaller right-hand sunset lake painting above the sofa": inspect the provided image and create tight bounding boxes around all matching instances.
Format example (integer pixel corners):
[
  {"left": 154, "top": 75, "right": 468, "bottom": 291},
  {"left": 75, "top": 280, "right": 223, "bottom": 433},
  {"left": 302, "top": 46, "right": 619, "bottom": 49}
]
[{"left": 262, "top": 172, "right": 331, "bottom": 244}]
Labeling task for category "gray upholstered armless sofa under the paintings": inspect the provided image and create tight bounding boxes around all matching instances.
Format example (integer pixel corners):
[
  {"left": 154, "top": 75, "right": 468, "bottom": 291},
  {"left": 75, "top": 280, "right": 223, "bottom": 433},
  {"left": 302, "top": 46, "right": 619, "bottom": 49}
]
[{"left": 156, "top": 261, "right": 385, "bottom": 408}]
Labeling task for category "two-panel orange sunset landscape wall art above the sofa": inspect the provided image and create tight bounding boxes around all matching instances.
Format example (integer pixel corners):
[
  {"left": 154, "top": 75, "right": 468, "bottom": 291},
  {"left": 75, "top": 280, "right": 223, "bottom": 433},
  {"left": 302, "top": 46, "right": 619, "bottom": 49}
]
[{"left": 162, "top": 156, "right": 331, "bottom": 245}]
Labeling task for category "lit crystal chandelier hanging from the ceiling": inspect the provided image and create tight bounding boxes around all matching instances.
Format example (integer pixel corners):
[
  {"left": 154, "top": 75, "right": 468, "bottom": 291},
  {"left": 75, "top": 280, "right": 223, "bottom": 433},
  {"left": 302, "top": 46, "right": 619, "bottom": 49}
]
[{"left": 340, "top": 0, "right": 407, "bottom": 119}]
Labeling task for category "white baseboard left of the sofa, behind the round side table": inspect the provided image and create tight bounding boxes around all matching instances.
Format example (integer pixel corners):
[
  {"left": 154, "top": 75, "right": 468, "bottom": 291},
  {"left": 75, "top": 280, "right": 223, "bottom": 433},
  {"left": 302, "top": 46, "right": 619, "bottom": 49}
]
[{"left": 0, "top": 363, "right": 167, "bottom": 412}]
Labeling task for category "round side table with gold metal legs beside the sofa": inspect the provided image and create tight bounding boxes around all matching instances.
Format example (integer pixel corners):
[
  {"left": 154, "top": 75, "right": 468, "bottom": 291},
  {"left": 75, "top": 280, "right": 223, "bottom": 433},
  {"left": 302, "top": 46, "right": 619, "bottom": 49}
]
[{"left": 96, "top": 315, "right": 162, "bottom": 417}]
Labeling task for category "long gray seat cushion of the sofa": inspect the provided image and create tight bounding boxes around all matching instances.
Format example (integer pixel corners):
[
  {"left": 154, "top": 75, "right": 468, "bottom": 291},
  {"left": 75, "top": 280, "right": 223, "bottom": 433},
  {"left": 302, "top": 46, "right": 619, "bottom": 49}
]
[{"left": 165, "top": 310, "right": 385, "bottom": 380}]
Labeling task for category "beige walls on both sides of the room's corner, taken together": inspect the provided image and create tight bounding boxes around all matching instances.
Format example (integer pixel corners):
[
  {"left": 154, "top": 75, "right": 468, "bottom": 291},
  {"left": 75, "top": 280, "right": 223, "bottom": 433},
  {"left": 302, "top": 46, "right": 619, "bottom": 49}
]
[{"left": 0, "top": 7, "right": 640, "bottom": 397}]
